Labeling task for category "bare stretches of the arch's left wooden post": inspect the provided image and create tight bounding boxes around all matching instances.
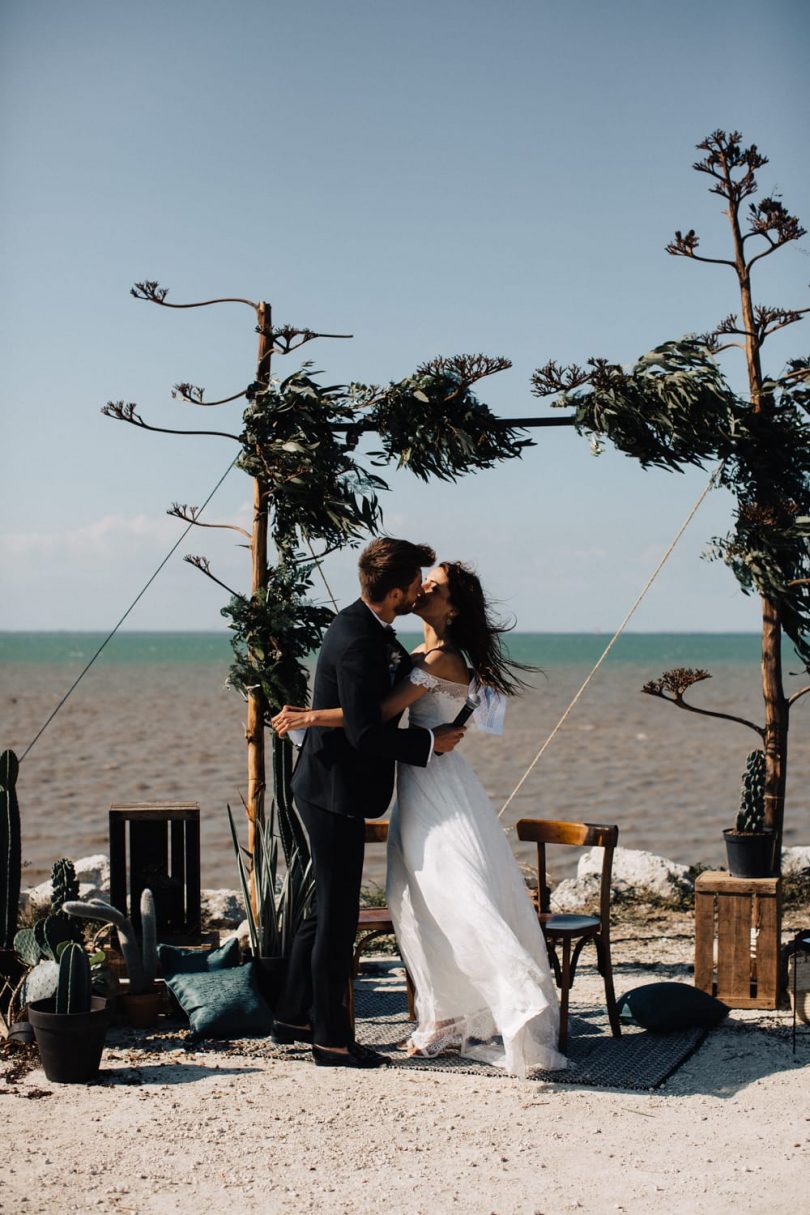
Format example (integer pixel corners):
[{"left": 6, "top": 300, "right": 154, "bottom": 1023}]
[{"left": 247, "top": 300, "right": 273, "bottom": 912}]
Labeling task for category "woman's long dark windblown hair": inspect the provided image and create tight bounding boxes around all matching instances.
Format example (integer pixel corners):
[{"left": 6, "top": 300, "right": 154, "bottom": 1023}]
[{"left": 438, "top": 561, "right": 536, "bottom": 696}]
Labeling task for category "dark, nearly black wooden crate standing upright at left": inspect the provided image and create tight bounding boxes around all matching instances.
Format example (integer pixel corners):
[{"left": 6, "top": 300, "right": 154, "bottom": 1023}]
[{"left": 109, "top": 802, "right": 200, "bottom": 944}]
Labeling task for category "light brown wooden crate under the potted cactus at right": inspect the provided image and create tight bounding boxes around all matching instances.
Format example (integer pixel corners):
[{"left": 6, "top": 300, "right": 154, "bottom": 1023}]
[{"left": 695, "top": 872, "right": 782, "bottom": 1008}]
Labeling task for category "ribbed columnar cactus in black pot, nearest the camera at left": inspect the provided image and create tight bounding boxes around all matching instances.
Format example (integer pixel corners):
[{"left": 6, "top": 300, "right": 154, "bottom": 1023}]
[{"left": 28, "top": 940, "right": 109, "bottom": 1084}]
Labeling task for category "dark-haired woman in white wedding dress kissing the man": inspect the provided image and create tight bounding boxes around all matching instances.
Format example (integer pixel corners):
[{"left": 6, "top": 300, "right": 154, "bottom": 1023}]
[{"left": 272, "top": 561, "right": 566, "bottom": 1075}]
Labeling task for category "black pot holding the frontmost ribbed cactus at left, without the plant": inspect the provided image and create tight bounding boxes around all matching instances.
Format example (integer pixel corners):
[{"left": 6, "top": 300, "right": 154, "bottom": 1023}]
[{"left": 28, "top": 995, "right": 109, "bottom": 1084}]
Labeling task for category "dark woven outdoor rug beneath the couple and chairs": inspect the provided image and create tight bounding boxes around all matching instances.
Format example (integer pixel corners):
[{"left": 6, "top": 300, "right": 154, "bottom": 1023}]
[{"left": 344, "top": 974, "right": 706, "bottom": 1090}]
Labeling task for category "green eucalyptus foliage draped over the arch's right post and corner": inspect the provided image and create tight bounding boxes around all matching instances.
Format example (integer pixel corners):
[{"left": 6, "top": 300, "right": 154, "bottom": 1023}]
[{"left": 548, "top": 338, "right": 810, "bottom": 663}]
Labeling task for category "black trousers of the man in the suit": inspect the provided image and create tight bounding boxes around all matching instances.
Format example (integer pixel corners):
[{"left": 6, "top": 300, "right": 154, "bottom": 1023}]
[{"left": 276, "top": 799, "right": 366, "bottom": 1046}]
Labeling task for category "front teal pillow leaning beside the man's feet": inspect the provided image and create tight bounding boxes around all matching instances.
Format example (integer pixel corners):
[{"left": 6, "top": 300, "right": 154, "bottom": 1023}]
[{"left": 166, "top": 962, "right": 273, "bottom": 1038}]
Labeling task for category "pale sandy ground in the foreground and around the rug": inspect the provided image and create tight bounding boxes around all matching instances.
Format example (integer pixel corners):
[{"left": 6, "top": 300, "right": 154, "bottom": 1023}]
[{"left": 0, "top": 912, "right": 810, "bottom": 1215}]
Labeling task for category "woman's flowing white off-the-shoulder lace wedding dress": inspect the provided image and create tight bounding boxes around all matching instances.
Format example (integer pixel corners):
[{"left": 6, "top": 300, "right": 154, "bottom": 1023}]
[{"left": 386, "top": 669, "right": 566, "bottom": 1075}]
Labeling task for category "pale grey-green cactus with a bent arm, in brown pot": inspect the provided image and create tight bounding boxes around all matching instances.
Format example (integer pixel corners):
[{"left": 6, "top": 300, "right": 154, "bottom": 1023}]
[{"left": 62, "top": 889, "right": 160, "bottom": 1027}]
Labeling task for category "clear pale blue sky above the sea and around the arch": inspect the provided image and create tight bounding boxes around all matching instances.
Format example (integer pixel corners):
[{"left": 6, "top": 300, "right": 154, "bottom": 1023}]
[{"left": 0, "top": 0, "right": 810, "bottom": 632}]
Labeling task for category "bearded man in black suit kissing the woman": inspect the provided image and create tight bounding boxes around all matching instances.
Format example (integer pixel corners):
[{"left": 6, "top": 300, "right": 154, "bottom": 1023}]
[{"left": 273, "top": 537, "right": 464, "bottom": 1068}]
